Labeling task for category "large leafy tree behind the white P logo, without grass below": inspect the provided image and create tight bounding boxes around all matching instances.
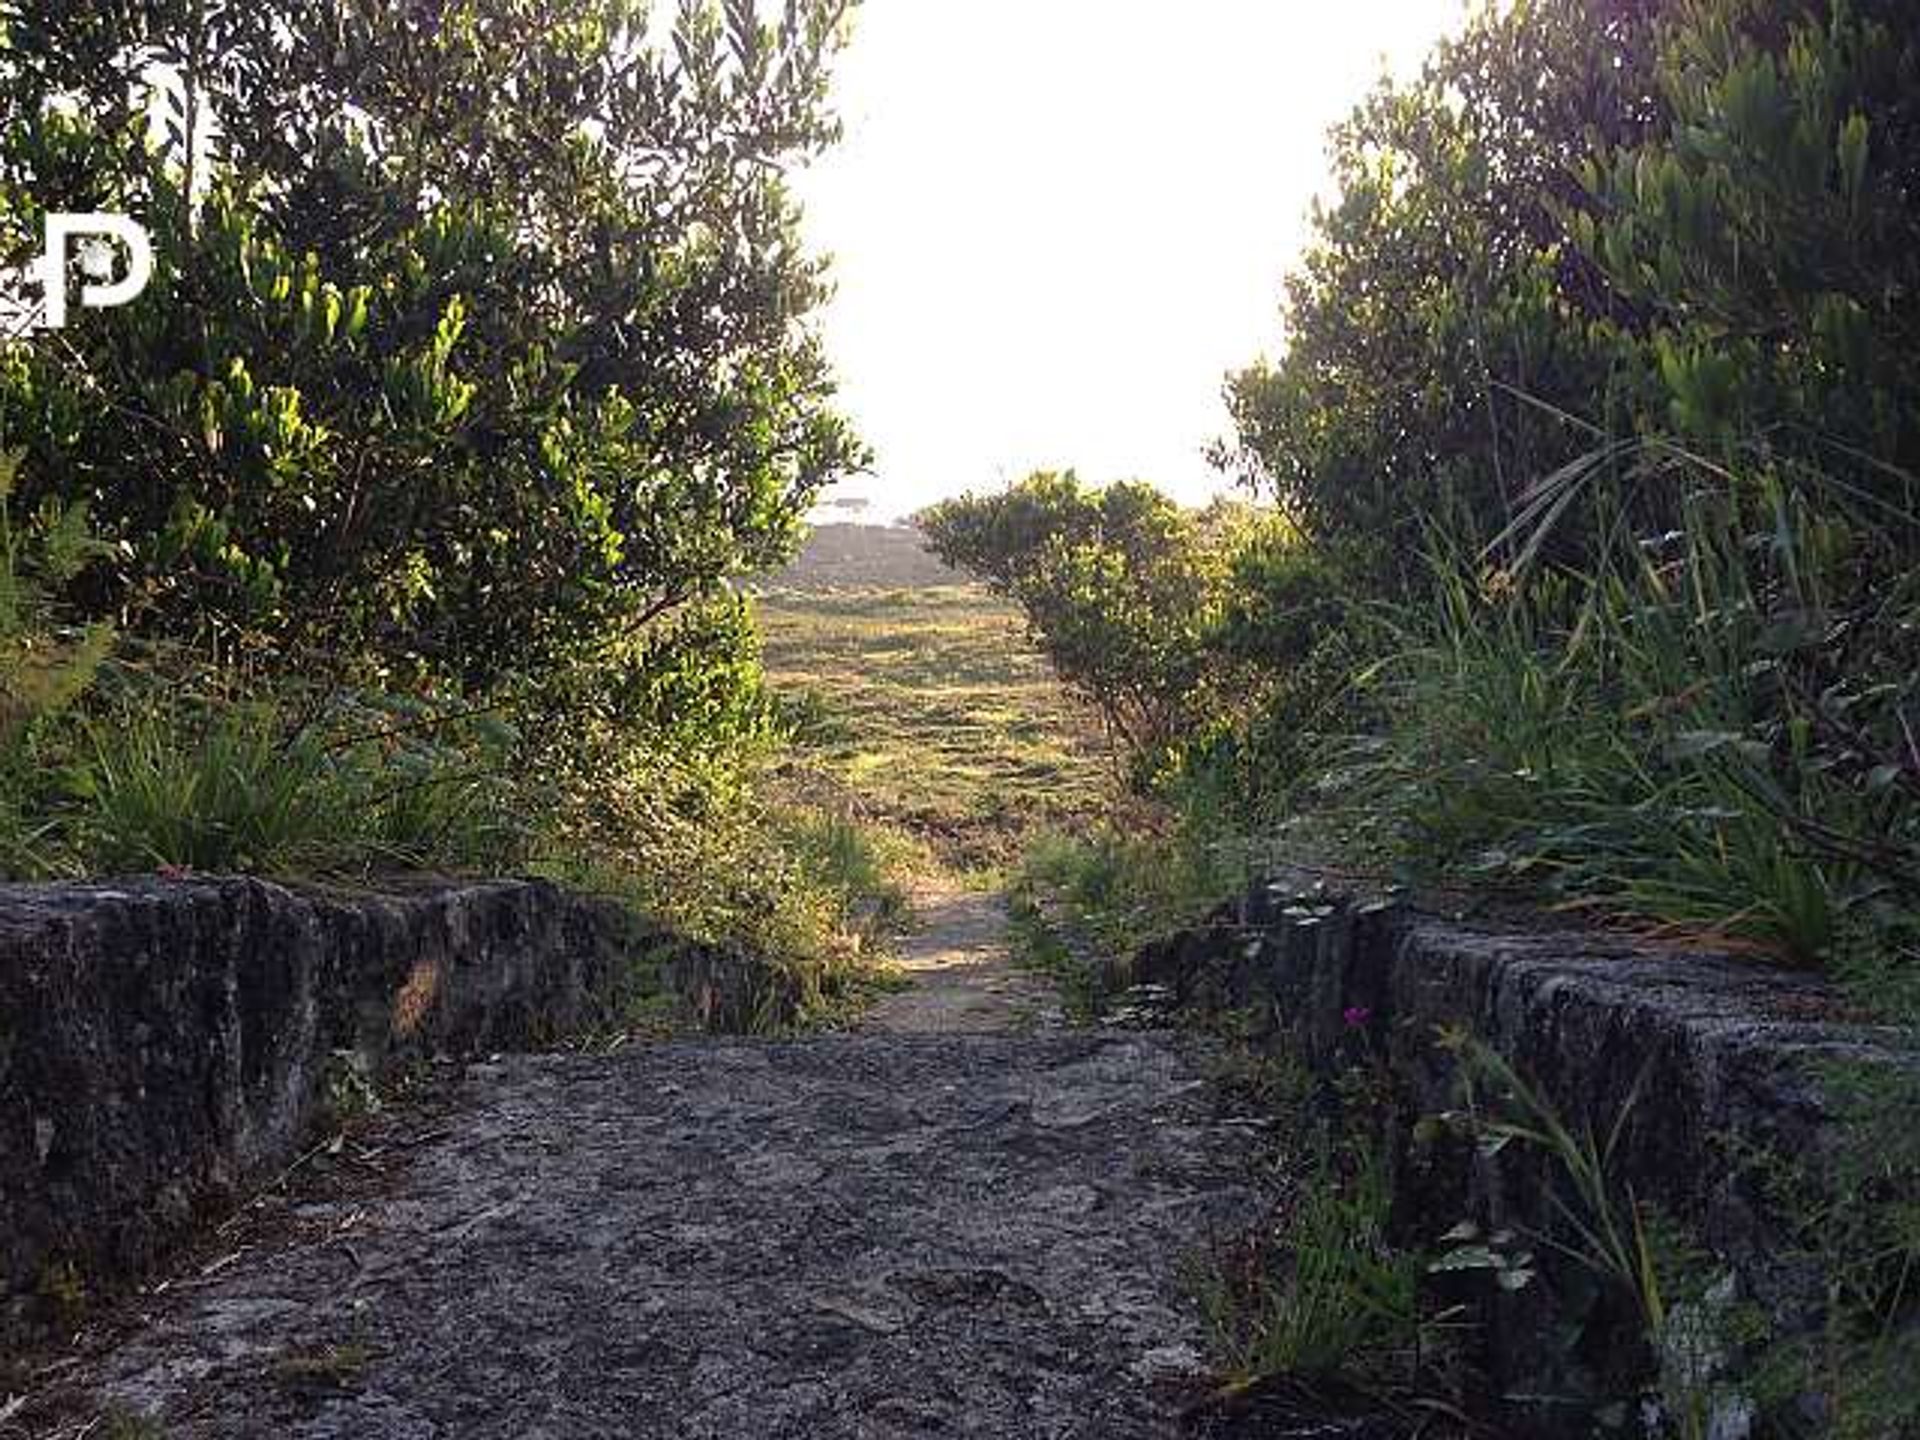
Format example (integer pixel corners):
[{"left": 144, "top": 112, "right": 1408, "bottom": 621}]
[{"left": 0, "top": 0, "right": 858, "bottom": 689}]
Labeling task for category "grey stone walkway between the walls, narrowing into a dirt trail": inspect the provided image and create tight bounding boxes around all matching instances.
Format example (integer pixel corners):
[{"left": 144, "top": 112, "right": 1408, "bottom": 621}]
[{"left": 37, "top": 891, "right": 1260, "bottom": 1440}]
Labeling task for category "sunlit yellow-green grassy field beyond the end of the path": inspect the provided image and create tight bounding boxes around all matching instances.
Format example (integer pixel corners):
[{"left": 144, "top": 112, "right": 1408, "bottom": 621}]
[{"left": 756, "top": 584, "right": 1110, "bottom": 872}]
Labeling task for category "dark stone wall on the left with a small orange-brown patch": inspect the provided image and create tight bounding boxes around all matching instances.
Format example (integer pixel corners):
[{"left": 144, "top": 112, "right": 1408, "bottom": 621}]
[{"left": 0, "top": 877, "right": 778, "bottom": 1336}]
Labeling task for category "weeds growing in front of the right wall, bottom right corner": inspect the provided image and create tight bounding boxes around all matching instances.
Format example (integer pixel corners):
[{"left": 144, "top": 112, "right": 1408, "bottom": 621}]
[{"left": 1440, "top": 1031, "right": 1920, "bottom": 1440}]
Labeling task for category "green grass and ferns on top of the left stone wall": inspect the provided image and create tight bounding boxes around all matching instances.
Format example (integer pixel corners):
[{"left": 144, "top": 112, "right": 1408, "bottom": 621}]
[{"left": 0, "top": 455, "right": 524, "bottom": 877}]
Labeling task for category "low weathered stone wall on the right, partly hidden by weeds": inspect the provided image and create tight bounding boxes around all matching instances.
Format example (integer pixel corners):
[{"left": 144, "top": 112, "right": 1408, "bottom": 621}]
[{"left": 1114, "top": 876, "right": 1920, "bottom": 1436}]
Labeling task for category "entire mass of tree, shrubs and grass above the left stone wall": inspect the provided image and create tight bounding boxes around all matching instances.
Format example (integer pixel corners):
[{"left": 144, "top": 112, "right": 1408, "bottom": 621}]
[{"left": 0, "top": 0, "right": 870, "bottom": 1029}]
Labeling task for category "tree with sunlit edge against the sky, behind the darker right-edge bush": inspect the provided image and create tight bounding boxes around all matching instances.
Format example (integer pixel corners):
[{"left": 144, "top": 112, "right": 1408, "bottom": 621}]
[{"left": 1217, "top": 0, "right": 1661, "bottom": 591}]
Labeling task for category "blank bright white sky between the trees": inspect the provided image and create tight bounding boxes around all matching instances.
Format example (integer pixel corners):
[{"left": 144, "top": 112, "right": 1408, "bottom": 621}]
[{"left": 799, "top": 0, "right": 1465, "bottom": 520}]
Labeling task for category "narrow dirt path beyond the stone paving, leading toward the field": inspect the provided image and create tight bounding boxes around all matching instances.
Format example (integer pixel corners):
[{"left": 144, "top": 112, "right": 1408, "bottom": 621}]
[{"left": 866, "top": 883, "right": 1062, "bottom": 1035}]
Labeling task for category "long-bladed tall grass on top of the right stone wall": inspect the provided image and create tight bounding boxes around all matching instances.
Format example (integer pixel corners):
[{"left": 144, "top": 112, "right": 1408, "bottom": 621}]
[{"left": 1327, "top": 455, "right": 1920, "bottom": 964}]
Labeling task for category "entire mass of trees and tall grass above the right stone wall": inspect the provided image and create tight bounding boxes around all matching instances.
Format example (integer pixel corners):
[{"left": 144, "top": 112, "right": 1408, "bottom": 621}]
[{"left": 1198, "top": 0, "right": 1920, "bottom": 991}]
